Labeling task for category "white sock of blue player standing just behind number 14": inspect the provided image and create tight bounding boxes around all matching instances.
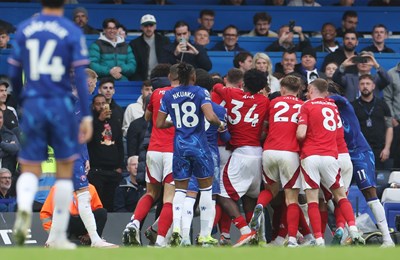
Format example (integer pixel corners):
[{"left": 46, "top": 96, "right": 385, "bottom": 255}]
[{"left": 77, "top": 191, "right": 101, "bottom": 244}]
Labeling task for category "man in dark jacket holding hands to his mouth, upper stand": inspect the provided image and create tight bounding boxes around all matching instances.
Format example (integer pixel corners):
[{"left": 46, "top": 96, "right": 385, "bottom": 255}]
[{"left": 161, "top": 21, "right": 212, "bottom": 71}]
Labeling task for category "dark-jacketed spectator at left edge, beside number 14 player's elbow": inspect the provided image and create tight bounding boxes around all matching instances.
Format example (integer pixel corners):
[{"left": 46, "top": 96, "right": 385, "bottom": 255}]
[{"left": 0, "top": 80, "right": 20, "bottom": 136}]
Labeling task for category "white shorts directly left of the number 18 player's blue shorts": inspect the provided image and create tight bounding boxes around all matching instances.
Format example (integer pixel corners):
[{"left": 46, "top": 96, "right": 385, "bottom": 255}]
[{"left": 146, "top": 151, "right": 174, "bottom": 184}]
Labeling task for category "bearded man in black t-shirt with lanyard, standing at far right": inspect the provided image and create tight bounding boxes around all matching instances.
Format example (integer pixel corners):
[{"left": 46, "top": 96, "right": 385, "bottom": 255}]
[{"left": 352, "top": 74, "right": 393, "bottom": 170}]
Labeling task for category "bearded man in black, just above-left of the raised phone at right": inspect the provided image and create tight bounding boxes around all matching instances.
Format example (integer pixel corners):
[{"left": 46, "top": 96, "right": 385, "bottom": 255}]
[{"left": 321, "top": 30, "right": 358, "bottom": 73}]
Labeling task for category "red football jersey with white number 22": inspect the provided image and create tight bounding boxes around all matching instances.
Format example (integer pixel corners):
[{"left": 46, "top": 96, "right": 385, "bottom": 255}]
[{"left": 264, "top": 96, "right": 303, "bottom": 152}]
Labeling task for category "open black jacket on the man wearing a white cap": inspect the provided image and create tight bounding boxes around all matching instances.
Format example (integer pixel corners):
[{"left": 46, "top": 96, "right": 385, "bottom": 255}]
[{"left": 129, "top": 33, "right": 170, "bottom": 80}]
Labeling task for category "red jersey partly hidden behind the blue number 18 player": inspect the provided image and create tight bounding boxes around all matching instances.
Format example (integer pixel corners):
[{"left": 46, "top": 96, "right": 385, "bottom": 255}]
[{"left": 147, "top": 87, "right": 175, "bottom": 153}]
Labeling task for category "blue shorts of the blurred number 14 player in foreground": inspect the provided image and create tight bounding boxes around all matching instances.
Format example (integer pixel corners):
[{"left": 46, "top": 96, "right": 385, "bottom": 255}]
[{"left": 19, "top": 97, "right": 79, "bottom": 163}]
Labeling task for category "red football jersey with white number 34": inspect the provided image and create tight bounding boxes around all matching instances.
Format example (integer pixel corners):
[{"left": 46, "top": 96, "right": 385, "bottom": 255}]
[{"left": 214, "top": 85, "right": 269, "bottom": 148}]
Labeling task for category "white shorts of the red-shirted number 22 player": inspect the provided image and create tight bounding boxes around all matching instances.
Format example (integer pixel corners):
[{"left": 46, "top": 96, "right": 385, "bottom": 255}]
[{"left": 262, "top": 150, "right": 302, "bottom": 189}]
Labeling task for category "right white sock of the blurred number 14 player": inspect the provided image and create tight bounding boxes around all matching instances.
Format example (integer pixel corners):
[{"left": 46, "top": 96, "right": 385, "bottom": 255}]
[{"left": 48, "top": 179, "right": 73, "bottom": 242}]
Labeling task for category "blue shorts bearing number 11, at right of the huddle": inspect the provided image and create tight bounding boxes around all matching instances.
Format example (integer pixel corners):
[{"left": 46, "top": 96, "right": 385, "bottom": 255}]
[{"left": 350, "top": 151, "right": 376, "bottom": 190}]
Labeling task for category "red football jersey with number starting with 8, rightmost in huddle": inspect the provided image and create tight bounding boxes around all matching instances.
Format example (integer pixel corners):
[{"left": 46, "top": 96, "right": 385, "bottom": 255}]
[{"left": 299, "top": 98, "right": 340, "bottom": 159}]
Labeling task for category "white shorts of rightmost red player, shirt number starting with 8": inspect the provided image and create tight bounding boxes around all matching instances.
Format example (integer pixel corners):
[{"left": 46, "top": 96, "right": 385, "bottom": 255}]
[{"left": 301, "top": 155, "right": 343, "bottom": 189}]
